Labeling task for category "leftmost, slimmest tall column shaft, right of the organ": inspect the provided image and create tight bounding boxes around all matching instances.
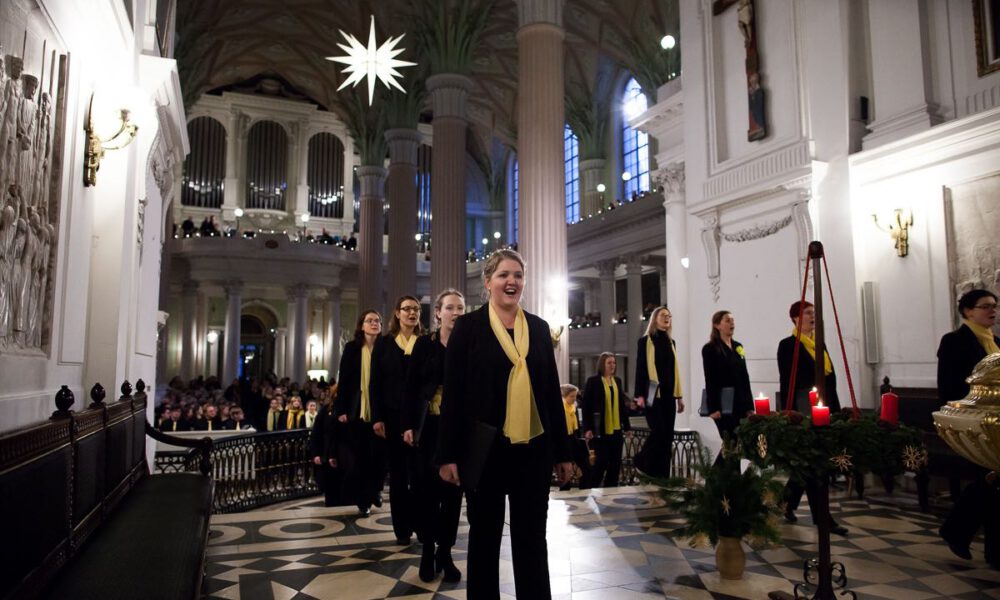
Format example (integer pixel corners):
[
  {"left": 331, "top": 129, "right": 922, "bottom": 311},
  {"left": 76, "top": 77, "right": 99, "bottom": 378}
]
[{"left": 358, "top": 167, "right": 386, "bottom": 313}]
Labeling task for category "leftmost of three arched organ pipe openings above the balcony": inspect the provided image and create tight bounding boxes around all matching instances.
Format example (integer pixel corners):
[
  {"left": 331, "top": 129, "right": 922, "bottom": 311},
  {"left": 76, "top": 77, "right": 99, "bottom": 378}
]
[{"left": 181, "top": 117, "right": 226, "bottom": 208}]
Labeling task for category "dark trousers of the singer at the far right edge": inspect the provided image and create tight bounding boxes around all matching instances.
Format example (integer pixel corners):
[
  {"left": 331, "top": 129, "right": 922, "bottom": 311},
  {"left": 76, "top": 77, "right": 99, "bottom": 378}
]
[{"left": 941, "top": 478, "right": 1000, "bottom": 568}]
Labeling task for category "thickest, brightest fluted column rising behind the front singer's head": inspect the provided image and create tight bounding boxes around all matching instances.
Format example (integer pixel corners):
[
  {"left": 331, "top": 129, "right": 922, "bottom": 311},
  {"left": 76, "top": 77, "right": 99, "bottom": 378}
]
[{"left": 516, "top": 0, "right": 569, "bottom": 381}]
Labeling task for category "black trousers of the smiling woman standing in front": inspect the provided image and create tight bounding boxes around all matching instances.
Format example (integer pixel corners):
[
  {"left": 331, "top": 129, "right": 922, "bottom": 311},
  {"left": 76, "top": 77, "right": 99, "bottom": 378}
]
[{"left": 466, "top": 436, "right": 552, "bottom": 600}]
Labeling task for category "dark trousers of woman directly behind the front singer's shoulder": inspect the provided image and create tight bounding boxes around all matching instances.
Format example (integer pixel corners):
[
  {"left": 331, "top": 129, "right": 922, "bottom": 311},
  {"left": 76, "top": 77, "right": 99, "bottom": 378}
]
[{"left": 412, "top": 415, "right": 462, "bottom": 548}]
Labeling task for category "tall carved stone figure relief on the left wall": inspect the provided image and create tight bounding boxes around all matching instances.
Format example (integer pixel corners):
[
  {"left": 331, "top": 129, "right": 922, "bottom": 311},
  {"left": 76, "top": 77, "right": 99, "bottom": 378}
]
[{"left": 0, "top": 1, "right": 69, "bottom": 353}]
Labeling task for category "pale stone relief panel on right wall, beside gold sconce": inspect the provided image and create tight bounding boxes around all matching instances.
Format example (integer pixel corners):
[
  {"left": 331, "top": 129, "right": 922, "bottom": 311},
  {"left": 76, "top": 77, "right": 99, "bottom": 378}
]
[{"left": 948, "top": 174, "right": 1000, "bottom": 308}]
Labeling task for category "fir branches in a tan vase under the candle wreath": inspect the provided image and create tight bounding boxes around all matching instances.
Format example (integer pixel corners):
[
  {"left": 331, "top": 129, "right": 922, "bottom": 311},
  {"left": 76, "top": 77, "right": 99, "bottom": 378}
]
[{"left": 654, "top": 444, "right": 783, "bottom": 579}]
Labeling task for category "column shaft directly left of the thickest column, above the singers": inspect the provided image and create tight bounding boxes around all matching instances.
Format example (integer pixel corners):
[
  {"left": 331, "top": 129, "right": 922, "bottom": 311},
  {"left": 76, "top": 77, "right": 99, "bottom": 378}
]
[{"left": 427, "top": 73, "right": 472, "bottom": 294}]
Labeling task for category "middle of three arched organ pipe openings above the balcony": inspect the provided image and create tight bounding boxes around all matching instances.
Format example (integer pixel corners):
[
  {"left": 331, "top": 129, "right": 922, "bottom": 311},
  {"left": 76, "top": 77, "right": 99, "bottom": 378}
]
[{"left": 247, "top": 121, "right": 288, "bottom": 210}]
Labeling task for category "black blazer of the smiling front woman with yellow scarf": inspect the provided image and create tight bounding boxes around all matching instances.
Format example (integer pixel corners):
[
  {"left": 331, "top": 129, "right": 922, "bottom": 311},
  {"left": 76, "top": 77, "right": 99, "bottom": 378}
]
[{"left": 435, "top": 304, "right": 572, "bottom": 465}]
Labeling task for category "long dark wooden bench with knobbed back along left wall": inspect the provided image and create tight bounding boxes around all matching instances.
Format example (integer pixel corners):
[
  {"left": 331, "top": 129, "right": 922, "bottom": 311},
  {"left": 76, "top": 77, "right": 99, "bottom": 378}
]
[{"left": 0, "top": 380, "right": 213, "bottom": 600}]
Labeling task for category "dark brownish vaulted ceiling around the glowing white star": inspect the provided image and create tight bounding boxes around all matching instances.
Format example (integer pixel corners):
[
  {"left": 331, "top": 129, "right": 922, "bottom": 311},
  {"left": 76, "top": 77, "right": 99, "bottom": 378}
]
[{"left": 176, "top": 0, "right": 678, "bottom": 149}]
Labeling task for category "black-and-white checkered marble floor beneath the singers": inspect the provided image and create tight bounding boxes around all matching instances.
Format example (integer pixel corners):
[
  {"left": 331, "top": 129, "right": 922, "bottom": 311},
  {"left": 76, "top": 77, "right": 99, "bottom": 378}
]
[{"left": 204, "top": 487, "right": 1000, "bottom": 600}]
